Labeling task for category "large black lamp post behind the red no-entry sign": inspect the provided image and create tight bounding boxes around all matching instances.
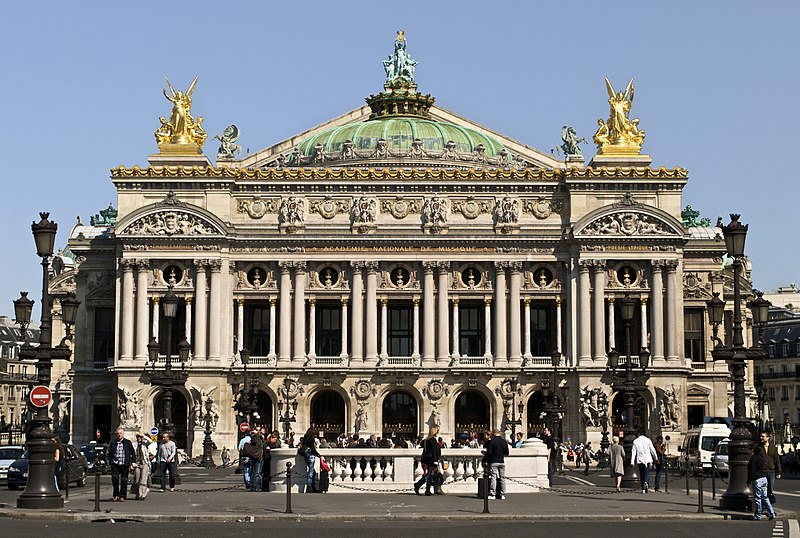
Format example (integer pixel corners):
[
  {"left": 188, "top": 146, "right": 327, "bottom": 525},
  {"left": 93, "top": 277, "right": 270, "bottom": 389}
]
[{"left": 14, "top": 213, "right": 80, "bottom": 509}]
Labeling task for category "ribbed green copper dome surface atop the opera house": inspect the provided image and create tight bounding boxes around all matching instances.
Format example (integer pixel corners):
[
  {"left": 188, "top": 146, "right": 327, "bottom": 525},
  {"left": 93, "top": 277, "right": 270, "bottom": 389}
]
[{"left": 298, "top": 117, "right": 510, "bottom": 157}]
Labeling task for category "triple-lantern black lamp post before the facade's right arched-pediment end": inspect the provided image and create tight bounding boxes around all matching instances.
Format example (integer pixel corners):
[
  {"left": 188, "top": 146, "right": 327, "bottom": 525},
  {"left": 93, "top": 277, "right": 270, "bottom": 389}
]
[{"left": 608, "top": 294, "right": 650, "bottom": 489}]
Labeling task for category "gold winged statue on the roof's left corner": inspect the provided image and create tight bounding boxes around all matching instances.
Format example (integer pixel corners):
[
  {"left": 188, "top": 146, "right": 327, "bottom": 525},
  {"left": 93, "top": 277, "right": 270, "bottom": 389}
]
[{"left": 155, "top": 77, "right": 208, "bottom": 153}]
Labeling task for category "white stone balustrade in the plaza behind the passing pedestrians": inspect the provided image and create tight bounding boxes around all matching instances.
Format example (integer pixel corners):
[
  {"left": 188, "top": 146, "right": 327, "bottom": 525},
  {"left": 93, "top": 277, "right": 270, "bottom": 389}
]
[{"left": 270, "top": 439, "right": 548, "bottom": 493}]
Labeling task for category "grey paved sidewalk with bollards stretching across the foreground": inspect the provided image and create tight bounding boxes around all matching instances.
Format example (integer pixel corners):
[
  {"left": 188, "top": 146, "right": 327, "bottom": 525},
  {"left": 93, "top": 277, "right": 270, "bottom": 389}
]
[{"left": 0, "top": 467, "right": 797, "bottom": 522}]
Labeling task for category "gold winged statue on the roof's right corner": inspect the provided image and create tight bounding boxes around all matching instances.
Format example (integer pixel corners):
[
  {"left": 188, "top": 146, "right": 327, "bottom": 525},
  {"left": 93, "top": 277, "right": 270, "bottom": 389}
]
[{"left": 594, "top": 78, "right": 644, "bottom": 155}]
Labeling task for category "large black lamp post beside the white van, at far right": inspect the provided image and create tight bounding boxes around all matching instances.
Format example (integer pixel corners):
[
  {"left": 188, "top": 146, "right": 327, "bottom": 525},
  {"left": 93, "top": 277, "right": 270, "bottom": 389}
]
[{"left": 706, "top": 213, "right": 769, "bottom": 511}]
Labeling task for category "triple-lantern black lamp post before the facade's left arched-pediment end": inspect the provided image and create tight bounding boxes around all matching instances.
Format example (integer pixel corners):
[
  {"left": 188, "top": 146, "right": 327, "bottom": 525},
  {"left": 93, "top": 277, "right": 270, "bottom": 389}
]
[{"left": 147, "top": 285, "right": 192, "bottom": 486}]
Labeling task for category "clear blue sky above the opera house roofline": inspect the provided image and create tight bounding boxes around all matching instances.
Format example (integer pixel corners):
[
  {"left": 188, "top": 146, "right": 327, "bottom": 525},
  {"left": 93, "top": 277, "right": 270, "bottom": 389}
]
[{"left": 0, "top": 0, "right": 800, "bottom": 314}]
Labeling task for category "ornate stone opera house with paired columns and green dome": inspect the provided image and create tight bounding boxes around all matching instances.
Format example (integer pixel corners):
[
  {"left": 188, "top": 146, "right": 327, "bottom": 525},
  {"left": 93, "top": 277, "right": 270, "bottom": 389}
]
[{"left": 57, "top": 35, "right": 756, "bottom": 454}]
